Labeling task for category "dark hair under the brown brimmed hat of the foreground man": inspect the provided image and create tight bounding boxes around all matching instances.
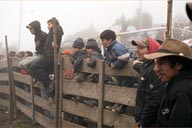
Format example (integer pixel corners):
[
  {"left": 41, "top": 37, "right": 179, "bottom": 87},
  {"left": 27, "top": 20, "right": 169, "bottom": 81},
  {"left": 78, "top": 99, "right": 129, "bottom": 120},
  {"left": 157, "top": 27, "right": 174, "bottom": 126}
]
[{"left": 158, "top": 56, "right": 192, "bottom": 70}]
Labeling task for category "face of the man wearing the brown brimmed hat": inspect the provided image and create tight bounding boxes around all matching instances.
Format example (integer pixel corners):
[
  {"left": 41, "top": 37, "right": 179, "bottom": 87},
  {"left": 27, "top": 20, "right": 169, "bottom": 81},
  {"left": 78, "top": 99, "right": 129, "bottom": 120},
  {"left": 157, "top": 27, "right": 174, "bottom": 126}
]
[{"left": 154, "top": 59, "right": 182, "bottom": 83}]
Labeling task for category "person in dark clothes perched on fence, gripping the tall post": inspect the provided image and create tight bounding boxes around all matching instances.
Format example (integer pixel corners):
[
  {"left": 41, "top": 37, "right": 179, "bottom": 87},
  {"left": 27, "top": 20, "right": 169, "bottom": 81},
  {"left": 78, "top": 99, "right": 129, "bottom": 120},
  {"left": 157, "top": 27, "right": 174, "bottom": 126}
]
[{"left": 31, "top": 18, "right": 63, "bottom": 98}]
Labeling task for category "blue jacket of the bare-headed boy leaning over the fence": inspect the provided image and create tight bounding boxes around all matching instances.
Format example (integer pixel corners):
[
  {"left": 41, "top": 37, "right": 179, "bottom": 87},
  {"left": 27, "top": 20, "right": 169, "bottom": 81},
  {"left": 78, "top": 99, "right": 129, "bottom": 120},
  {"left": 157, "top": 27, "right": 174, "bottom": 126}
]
[{"left": 104, "top": 40, "right": 129, "bottom": 69}]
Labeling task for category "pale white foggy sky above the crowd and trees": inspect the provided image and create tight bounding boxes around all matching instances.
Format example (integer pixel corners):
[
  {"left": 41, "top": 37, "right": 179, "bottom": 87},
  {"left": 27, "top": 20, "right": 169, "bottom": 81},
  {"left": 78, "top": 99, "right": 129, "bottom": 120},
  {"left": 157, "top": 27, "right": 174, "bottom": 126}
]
[{"left": 0, "top": 0, "right": 187, "bottom": 51}]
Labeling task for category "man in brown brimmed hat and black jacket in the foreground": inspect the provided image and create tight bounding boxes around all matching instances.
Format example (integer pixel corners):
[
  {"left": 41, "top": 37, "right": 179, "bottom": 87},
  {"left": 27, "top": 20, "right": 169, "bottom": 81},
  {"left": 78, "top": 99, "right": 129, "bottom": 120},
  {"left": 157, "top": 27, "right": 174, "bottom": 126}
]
[{"left": 144, "top": 39, "right": 192, "bottom": 128}]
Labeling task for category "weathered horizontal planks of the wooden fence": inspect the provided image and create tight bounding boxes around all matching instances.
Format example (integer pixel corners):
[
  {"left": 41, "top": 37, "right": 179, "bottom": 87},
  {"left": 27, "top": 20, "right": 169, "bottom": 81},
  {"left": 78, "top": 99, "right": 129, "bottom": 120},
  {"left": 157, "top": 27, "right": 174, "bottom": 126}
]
[{"left": 0, "top": 58, "right": 138, "bottom": 128}]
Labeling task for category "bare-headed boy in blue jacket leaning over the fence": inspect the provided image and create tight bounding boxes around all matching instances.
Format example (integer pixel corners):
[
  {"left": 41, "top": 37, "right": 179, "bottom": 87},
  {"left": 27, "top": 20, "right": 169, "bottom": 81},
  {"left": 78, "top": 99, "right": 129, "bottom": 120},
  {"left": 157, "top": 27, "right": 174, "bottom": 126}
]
[{"left": 100, "top": 30, "right": 133, "bottom": 113}]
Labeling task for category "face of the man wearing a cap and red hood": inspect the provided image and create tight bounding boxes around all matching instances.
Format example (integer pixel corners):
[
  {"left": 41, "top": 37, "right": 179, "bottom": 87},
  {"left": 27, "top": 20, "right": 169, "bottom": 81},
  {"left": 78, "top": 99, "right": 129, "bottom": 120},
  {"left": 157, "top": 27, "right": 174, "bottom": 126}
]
[{"left": 136, "top": 45, "right": 148, "bottom": 61}]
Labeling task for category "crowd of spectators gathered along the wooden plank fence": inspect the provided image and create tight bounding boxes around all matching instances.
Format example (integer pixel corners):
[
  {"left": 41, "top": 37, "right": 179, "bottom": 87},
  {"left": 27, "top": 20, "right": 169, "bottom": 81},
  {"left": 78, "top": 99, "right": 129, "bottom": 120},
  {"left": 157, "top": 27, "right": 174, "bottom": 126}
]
[{"left": 0, "top": 3, "right": 192, "bottom": 128}]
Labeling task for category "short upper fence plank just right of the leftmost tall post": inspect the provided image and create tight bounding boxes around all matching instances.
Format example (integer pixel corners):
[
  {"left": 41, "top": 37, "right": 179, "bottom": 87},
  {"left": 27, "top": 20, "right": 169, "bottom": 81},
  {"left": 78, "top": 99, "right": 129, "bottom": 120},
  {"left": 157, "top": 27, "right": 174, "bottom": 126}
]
[{"left": 13, "top": 72, "right": 32, "bottom": 85}]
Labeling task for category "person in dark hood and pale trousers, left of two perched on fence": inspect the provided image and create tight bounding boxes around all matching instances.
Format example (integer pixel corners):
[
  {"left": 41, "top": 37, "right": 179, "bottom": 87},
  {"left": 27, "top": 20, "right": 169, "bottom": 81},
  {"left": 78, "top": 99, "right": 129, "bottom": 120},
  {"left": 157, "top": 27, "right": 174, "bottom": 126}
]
[{"left": 19, "top": 20, "right": 47, "bottom": 74}]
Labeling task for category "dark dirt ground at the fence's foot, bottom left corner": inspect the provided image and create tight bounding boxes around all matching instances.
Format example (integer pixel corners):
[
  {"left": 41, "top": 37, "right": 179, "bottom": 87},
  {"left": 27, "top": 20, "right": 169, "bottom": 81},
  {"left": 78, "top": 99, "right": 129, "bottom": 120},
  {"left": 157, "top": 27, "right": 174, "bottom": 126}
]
[{"left": 0, "top": 110, "right": 44, "bottom": 128}]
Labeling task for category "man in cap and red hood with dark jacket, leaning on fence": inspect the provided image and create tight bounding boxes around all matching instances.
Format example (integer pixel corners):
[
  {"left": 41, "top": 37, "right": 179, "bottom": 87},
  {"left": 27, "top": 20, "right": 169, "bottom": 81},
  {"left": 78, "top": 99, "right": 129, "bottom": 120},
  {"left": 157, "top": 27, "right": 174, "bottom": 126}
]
[{"left": 132, "top": 36, "right": 165, "bottom": 128}]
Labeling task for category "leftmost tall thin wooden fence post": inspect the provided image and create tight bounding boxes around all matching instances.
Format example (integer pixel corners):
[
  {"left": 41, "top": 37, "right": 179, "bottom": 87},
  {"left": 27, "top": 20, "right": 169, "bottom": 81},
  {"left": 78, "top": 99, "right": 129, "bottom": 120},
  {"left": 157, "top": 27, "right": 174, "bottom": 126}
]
[{"left": 5, "top": 36, "right": 16, "bottom": 124}]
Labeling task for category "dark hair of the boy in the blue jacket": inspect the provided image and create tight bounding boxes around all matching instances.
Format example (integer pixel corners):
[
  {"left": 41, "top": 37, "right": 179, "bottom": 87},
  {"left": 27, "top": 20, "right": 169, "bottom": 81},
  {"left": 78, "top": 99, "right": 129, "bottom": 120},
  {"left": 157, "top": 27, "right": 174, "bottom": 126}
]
[{"left": 100, "top": 30, "right": 116, "bottom": 41}]
